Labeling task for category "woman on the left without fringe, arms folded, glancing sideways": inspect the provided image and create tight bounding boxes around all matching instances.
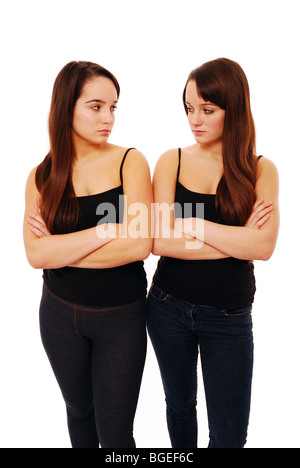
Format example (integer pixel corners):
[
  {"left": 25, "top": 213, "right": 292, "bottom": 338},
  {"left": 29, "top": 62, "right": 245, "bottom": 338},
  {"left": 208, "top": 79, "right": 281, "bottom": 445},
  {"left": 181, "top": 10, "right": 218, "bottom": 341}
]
[{"left": 24, "top": 62, "right": 152, "bottom": 448}]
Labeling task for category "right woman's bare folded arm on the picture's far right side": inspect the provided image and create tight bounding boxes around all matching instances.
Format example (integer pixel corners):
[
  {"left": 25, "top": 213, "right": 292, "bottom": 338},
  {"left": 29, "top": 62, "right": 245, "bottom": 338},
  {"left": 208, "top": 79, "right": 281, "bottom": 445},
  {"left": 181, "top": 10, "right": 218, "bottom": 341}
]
[{"left": 178, "top": 158, "right": 279, "bottom": 260}]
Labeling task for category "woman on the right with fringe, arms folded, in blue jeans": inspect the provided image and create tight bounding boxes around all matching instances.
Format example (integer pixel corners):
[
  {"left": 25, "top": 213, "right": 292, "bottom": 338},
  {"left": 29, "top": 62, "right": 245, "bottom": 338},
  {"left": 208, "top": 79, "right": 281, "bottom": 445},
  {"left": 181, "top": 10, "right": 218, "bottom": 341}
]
[{"left": 148, "top": 59, "right": 279, "bottom": 448}]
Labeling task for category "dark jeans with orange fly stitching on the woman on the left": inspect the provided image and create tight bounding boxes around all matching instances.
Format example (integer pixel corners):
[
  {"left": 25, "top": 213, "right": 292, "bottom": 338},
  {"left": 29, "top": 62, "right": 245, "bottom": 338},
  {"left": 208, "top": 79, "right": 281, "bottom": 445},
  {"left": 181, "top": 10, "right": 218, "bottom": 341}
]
[{"left": 40, "top": 287, "right": 147, "bottom": 448}]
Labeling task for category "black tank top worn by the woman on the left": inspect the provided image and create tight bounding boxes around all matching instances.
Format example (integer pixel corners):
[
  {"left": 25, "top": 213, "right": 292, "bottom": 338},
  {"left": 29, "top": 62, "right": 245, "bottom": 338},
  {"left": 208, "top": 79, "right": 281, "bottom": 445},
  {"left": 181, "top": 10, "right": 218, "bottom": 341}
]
[{"left": 43, "top": 148, "right": 147, "bottom": 308}]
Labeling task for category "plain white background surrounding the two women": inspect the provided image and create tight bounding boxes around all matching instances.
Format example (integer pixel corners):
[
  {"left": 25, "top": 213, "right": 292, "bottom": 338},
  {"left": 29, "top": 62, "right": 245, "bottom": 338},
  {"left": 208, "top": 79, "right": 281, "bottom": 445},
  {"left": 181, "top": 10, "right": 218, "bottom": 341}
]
[{"left": 0, "top": 0, "right": 300, "bottom": 448}]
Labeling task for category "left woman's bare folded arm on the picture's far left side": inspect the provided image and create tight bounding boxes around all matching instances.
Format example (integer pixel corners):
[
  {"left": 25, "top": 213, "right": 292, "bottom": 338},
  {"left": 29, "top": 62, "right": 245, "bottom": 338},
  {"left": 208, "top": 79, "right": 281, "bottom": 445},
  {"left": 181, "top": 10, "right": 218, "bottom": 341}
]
[{"left": 23, "top": 170, "right": 116, "bottom": 269}]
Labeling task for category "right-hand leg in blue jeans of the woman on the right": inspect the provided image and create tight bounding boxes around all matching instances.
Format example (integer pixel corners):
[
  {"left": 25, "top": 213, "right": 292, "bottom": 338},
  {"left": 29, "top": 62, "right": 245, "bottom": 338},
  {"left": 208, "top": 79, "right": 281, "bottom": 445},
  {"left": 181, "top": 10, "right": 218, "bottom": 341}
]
[{"left": 198, "top": 308, "right": 253, "bottom": 448}]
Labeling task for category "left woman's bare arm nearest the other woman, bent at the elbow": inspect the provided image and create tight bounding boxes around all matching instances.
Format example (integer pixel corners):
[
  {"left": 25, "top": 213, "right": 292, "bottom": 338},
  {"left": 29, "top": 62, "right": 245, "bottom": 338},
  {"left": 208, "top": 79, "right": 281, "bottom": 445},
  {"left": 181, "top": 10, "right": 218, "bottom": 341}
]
[{"left": 70, "top": 150, "right": 152, "bottom": 268}]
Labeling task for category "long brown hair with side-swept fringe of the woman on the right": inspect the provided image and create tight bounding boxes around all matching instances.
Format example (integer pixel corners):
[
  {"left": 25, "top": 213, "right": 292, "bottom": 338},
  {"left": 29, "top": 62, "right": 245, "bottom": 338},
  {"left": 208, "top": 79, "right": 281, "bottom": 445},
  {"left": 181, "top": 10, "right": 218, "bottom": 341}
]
[{"left": 183, "top": 58, "right": 257, "bottom": 226}]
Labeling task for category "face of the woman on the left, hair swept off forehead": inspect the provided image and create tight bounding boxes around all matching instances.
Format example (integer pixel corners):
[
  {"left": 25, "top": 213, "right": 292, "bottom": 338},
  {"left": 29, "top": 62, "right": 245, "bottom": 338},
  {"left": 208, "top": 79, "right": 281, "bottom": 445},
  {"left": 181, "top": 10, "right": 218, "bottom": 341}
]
[{"left": 73, "top": 76, "right": 118, "bottom": 145}]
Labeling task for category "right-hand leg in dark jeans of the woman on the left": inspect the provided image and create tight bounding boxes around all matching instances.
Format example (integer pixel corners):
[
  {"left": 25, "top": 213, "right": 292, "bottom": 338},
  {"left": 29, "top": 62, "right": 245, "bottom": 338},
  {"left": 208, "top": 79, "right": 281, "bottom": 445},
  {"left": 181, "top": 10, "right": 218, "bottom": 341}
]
[{"left": 87, "top": 301, "right": 147, "bottom": 448}]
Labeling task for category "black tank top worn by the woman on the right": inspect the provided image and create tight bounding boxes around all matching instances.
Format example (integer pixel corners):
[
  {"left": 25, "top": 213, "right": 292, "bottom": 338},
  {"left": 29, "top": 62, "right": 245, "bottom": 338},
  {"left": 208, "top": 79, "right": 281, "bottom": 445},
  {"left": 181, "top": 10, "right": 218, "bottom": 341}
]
[{"left": 153, "top": 149, "right": 256, "bottom": 309}]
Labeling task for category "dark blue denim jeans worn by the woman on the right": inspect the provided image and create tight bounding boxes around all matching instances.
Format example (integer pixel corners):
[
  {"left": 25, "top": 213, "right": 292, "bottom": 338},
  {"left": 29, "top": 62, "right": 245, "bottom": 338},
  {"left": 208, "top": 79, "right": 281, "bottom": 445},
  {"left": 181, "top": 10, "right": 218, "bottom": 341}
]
[{"left": 147, "top": 285, "right": 254, "bottom": 448}]
